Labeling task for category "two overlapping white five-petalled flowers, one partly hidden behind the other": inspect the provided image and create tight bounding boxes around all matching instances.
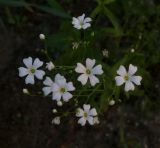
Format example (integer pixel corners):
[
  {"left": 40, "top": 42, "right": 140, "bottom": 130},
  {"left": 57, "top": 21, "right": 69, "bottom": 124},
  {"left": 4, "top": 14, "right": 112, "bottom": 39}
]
[{"left": 42, "top": 74, "right": 75, "bottom": 102}]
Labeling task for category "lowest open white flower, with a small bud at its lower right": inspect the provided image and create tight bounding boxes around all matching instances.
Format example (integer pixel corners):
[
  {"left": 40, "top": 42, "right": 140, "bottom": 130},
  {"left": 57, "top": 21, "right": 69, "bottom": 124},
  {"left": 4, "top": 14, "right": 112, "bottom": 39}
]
[{"left": 76, "top": 104, "right": 97, "bottom": 126}]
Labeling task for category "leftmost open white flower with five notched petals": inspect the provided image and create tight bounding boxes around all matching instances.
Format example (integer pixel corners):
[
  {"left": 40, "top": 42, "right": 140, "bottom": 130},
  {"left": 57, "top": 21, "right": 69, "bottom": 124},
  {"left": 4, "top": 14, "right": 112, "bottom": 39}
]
[{"left": 18, "top": 57, "right": 45, "bottom": 84}]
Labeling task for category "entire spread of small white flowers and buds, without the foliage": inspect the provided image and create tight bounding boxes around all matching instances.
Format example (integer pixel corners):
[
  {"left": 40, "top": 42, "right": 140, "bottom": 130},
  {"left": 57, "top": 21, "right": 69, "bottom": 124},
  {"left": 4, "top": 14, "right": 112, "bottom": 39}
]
[{"left": 18, "top": 14, "right": 142, "bottom": 126}]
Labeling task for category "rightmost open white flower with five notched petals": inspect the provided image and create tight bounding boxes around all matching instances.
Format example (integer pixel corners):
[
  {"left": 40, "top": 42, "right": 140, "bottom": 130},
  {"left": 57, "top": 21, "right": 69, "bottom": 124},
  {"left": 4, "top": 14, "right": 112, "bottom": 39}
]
[{"left": 115, "top": 64, "right": 142, "bottom": 91}]
